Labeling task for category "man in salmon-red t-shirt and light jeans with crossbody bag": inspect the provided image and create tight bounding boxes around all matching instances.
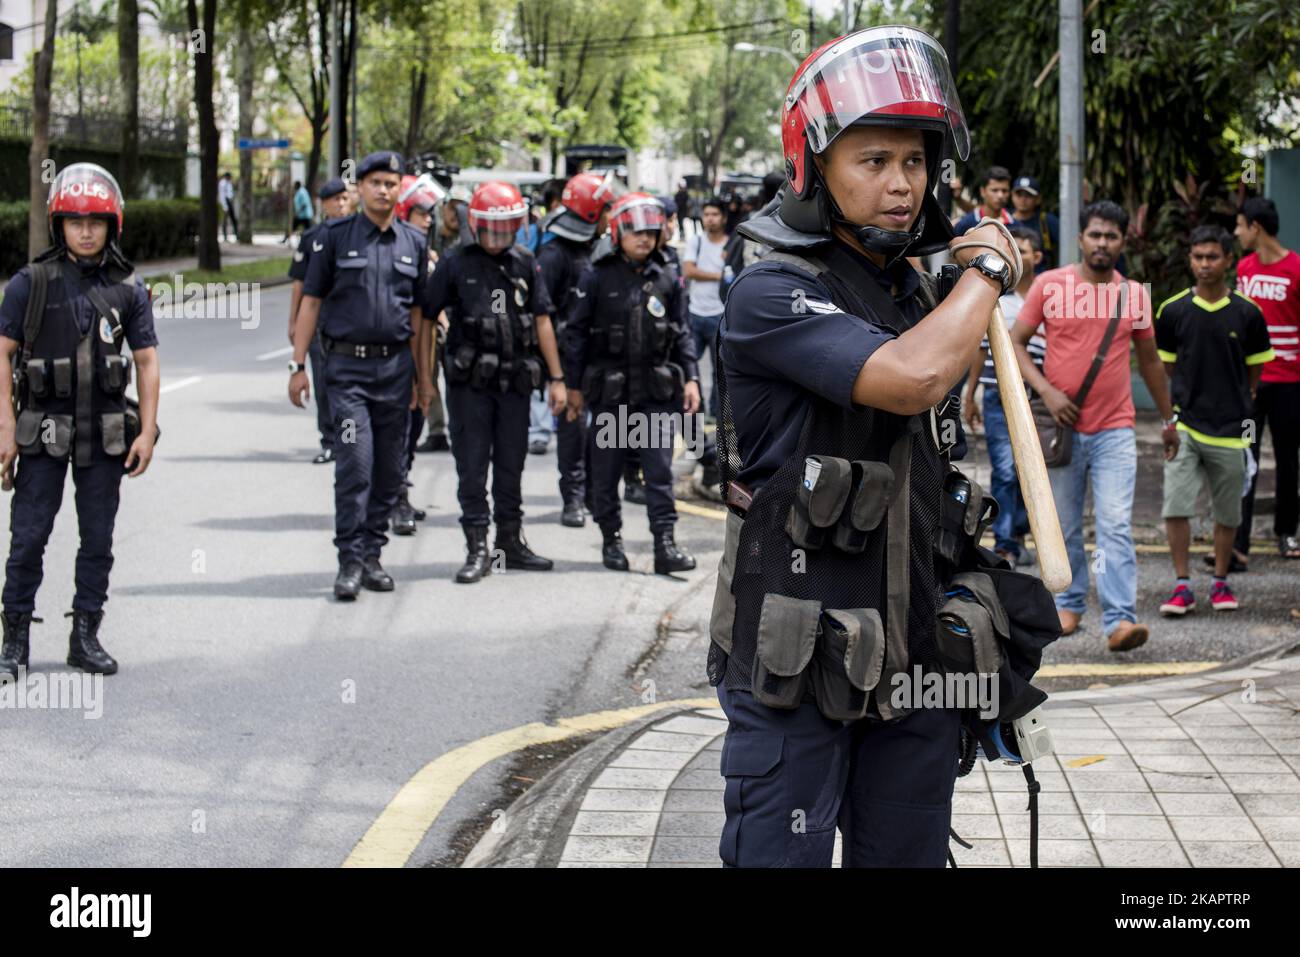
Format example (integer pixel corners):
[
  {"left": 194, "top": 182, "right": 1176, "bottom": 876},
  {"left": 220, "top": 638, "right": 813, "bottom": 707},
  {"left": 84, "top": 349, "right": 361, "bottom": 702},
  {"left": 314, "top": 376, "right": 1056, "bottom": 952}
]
[{"left": 1011, "top": 200, "right": 1179, "bottom": 651}]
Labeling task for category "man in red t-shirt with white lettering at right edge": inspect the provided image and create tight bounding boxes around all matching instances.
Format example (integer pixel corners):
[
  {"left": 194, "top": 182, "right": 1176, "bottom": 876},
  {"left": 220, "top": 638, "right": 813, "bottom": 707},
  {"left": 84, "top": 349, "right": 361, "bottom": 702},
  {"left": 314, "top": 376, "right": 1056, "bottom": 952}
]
[{"left": 1232, "top": 196, "right": 1300, "bottom": 571}]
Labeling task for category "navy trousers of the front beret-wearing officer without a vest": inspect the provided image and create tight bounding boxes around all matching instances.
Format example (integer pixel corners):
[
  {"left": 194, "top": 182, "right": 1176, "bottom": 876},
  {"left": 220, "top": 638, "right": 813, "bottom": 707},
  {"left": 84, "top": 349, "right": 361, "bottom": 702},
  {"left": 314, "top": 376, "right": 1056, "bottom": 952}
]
[{"left": 325, "top": 348, "right": 415, "bottom": 564}]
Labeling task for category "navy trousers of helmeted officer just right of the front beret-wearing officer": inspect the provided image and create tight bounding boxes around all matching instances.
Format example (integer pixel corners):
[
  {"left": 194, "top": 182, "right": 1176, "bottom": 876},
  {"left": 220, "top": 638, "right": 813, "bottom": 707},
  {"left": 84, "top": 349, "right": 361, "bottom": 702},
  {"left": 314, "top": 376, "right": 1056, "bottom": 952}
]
[{"left": 447, "top": 384, "right": 530, "bottom": 527}]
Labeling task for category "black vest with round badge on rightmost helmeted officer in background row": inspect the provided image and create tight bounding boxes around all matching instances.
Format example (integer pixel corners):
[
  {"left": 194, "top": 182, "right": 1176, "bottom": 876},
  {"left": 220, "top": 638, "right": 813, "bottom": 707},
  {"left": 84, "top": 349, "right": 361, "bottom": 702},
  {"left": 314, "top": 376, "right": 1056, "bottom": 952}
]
[{"left": 582, "top": 254, "right": 685, "bottom": 406}]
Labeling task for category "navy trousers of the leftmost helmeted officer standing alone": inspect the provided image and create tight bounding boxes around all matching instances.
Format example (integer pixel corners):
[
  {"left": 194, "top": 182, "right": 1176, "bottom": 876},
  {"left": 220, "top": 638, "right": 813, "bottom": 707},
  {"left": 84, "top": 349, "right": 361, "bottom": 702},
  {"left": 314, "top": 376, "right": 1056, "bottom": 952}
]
[{"left": 4, "top": 452, "right": 125, "bottom": 614}]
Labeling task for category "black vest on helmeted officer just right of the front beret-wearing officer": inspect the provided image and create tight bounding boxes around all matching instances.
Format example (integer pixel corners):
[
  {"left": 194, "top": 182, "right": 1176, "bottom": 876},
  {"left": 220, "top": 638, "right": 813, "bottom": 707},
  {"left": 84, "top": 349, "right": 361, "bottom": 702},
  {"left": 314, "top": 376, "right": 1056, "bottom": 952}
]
[{"left": 445, "top": 246, "right": 542, "bottom": 395}]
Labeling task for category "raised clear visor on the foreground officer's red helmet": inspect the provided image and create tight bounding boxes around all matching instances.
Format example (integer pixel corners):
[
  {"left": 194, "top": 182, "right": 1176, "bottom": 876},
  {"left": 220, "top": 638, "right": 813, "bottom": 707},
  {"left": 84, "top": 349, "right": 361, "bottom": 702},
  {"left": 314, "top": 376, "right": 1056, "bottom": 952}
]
[{"left": 785, "top": 26, "right": 970, "bottom": 160}]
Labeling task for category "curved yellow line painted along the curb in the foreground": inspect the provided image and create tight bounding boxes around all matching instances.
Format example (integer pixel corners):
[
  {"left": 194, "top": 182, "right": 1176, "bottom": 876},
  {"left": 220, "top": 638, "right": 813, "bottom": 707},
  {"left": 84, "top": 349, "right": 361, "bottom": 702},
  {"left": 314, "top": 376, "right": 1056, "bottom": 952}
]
[{"left": 342, "top": 698, "right": 718, "bottom": 867}]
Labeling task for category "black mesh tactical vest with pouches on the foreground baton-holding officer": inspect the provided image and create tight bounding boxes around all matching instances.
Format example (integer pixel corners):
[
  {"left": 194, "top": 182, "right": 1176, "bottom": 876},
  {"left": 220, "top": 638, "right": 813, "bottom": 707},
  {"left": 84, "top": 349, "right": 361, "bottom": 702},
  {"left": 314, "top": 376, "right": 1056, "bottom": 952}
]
[{"left": 709, "top": 248, "right": 950, "bottom": 720}]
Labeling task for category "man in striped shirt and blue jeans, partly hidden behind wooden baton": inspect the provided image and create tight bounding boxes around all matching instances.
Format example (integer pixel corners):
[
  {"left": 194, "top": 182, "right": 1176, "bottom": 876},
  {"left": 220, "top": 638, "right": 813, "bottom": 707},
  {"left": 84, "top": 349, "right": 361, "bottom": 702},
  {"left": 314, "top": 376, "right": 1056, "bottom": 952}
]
[{"left": 962, "top": 226, "right": 1045, "bottom": 564}]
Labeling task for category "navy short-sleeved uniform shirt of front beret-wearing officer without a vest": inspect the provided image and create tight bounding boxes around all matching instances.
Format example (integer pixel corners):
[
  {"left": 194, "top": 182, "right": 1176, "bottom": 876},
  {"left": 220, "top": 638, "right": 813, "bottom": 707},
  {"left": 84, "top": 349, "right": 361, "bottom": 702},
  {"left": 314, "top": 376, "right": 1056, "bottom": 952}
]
[{"left": 303, "top": 213, "right": 429, "bottom": 345}]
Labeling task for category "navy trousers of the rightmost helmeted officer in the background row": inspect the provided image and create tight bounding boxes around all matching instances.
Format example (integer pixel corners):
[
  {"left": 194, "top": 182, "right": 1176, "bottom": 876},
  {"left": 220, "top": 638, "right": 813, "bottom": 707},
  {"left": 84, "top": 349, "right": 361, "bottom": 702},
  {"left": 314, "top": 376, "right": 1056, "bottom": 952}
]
[{"left": 588, "top": 403, "right": 680, "bottom": 532}]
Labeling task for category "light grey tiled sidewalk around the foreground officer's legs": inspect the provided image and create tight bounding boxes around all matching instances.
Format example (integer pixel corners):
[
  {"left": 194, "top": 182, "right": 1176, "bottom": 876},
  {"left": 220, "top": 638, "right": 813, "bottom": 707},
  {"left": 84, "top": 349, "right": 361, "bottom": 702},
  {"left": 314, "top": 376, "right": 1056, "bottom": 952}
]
[{"left": 548, "top": 657, "right": 1300, "bottom": 867}]
